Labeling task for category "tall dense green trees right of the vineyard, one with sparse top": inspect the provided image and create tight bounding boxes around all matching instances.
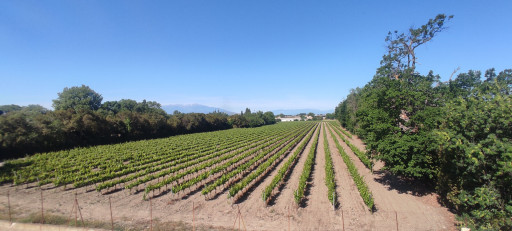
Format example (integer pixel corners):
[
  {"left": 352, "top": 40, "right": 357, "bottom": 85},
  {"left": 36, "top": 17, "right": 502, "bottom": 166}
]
[{"left": 335, "top": 15, "right": 512, "bottom": 230}]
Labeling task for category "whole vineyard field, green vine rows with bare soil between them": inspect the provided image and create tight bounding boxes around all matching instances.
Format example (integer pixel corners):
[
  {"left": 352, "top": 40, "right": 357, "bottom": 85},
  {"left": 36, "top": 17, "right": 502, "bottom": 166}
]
[{"left": 0, "top": 121, "right": 456, "bottom": 229}]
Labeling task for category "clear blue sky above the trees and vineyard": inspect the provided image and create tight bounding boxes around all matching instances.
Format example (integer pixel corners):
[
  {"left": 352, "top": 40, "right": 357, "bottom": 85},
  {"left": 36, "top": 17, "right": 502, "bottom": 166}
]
[{"left": 0, "top": 0, "right": 512, "bottom": 111}]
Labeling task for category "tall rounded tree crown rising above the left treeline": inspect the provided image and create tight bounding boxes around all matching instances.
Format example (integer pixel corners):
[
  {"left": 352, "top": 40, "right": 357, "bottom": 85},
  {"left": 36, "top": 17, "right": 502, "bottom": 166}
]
[{"left": 53, "top": 85, "right": 103, "bottom": 111}]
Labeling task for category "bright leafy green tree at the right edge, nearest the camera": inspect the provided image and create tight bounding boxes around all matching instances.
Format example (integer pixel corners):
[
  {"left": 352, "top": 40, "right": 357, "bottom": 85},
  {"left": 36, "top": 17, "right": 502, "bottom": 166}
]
[{"left": 435, "top": 81, "right": 512, "bottom": 229}]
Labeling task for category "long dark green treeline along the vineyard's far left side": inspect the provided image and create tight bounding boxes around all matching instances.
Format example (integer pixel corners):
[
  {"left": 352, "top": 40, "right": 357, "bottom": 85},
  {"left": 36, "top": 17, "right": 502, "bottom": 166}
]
[{"left": 0, "top": 85, "right": 276, "bottom": 159}]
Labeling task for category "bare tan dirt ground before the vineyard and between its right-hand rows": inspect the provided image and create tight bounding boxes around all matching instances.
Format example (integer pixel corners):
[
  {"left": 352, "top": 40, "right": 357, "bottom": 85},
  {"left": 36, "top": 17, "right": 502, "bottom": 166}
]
[{"left": 0, "top": 123, "right": 456, "bottom": 230}]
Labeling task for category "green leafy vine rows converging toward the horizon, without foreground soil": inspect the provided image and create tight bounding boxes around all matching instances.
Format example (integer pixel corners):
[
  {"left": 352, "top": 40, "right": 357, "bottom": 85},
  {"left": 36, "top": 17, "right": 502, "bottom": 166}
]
[{"left": 0, "top": 122, "right": 373, "bottom": 211}]
